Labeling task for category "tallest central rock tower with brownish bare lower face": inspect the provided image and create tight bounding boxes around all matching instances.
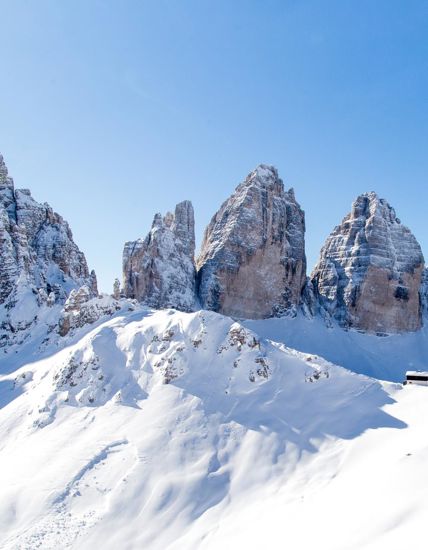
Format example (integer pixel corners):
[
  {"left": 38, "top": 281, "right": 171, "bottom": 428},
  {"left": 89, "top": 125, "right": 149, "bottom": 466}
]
[{"left": 197, "top": 165, "right": 306, "bottom": 319}]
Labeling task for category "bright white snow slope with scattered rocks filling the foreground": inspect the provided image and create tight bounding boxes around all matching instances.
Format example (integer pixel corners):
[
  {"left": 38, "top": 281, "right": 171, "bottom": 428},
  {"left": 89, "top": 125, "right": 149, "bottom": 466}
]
[{"left": 0, "top": 309, "right": 428, "bottom": 550}]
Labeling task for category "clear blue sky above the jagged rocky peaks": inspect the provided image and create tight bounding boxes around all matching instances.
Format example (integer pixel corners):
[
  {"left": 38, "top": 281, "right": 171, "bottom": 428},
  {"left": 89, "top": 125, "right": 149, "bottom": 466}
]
[{"left": 0, "top": 0, "right": 428, "bottom": 291}]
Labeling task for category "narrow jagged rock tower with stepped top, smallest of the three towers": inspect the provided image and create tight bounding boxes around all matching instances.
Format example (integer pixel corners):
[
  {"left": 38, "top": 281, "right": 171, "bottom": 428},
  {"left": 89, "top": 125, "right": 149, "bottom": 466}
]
[{"left": 123, "top": 201, "right": 196, "bottom": 311}]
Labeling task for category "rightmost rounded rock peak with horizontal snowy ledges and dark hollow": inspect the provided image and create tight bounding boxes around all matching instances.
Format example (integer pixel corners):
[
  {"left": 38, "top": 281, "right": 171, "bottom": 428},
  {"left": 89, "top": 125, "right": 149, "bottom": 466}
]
[{"left": 311, "top": 193, "right": 424, "bottom": 333}]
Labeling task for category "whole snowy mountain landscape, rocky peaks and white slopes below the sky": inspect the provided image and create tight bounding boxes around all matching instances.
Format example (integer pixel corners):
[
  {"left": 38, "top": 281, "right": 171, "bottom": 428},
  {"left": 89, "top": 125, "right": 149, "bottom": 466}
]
[{"left": 0, "top": 157, "right": 428, "bottom": 550}]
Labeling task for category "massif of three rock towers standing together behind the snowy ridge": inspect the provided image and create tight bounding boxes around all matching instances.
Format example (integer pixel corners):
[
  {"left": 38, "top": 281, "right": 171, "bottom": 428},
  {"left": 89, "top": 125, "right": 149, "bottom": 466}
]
[{"left": 119, "top": 164, "right": 427, "bottom": 335}]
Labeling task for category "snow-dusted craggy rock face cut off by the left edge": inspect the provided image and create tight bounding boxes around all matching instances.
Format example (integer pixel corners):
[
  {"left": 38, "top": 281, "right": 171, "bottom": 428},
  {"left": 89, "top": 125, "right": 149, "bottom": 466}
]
[{"left": 0, "top": 155, "right": 96, "bottom": 342}]
